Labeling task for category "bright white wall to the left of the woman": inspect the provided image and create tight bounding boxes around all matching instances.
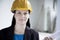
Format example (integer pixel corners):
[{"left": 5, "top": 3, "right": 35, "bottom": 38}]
[{"left": 0, "top": 0, "right": 13, "bottom": 29}]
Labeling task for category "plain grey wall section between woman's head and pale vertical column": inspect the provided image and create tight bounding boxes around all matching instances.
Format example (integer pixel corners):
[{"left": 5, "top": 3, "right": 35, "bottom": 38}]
[{"left": 29, "top": 0, "right": 44, "bottom": 31}]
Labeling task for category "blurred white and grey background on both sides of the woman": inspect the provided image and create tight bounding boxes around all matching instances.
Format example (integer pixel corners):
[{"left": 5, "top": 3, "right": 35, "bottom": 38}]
[{"left": 0, "top": 0, "right": 60, "bottom": 40}]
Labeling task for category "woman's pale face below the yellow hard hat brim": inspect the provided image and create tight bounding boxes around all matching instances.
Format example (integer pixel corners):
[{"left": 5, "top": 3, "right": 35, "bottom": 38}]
[{"left": 14, "top": 10, "right": 29, "bottom": 24}]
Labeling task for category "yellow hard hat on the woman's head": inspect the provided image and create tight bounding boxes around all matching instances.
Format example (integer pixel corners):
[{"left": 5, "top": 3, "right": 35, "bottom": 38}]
[{"left": 11, "top": 0, "right": 32, "bottom": 12}]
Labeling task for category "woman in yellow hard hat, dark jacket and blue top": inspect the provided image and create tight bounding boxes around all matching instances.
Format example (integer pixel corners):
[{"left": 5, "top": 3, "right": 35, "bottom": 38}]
[{"left": 0, "top": 0, "right": 39, "bottom": 40}]
